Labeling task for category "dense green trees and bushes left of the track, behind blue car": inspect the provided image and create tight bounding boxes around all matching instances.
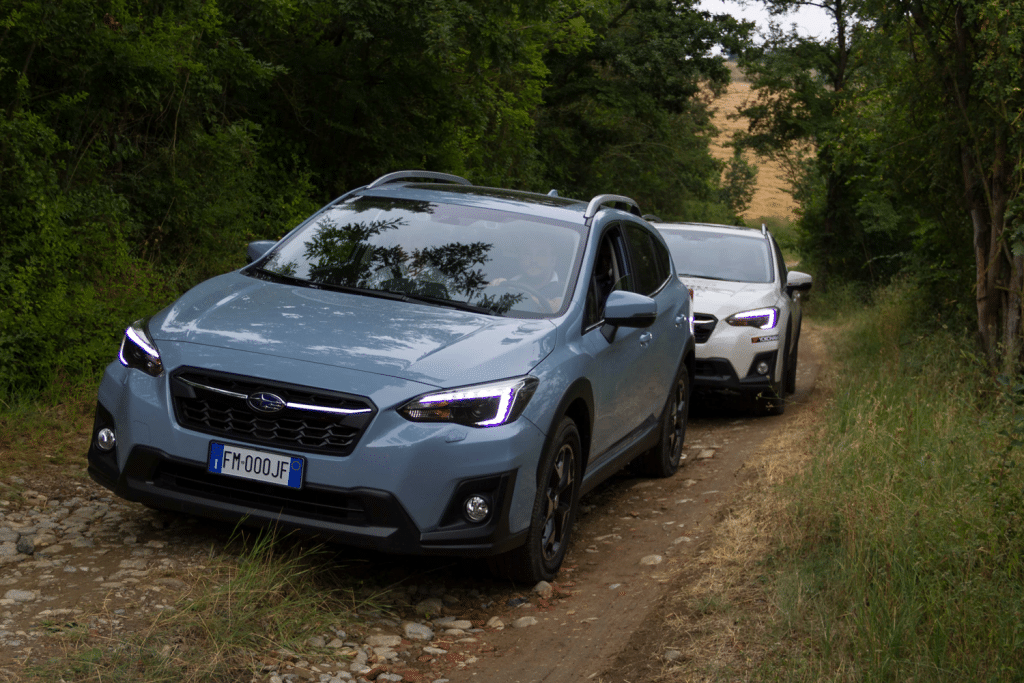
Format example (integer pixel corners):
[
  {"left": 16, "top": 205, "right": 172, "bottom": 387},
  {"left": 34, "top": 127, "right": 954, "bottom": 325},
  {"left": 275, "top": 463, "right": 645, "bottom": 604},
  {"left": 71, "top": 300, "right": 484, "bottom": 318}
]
[{"left": 0, "top": 0, "right": 750, "bottom": 396}]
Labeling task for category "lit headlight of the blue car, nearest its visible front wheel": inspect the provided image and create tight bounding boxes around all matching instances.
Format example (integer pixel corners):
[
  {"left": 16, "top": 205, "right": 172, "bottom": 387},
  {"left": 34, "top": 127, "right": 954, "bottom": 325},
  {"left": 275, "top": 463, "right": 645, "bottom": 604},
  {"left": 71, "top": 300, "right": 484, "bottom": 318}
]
[{"left": 398, "top": 377, "right": 538, "bottom": 427}]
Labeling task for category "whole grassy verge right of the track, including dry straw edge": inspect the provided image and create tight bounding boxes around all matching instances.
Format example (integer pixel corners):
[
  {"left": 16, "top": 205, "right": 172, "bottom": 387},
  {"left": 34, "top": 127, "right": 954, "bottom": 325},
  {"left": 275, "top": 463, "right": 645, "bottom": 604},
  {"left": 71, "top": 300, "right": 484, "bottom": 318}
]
[{"left": 656, "top": 285, "right": 1024, "bottom": 682}]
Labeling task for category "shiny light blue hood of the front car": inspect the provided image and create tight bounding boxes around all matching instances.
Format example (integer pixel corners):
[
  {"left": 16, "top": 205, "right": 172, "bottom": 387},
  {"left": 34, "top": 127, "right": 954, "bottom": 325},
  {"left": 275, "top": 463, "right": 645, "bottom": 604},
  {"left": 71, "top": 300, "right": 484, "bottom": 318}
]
[{"left": 150, "top": 272, "right": 556, "bottom": 387}]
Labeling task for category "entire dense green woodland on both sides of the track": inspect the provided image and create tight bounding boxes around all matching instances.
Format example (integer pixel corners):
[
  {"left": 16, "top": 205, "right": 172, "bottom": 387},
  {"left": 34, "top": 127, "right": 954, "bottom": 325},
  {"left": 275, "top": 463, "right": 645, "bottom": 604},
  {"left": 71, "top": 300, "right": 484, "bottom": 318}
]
[{"left": 0, "top": 0, "right": 1024, "bottom": 396}]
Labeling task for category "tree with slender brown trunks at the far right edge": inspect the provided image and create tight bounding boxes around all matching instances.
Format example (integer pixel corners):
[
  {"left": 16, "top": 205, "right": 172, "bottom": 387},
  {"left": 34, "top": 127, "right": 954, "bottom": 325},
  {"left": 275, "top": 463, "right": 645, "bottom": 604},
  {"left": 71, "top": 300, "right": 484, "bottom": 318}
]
[{"left": 851, "top": 0, "right": 1024, "bottom": 368}]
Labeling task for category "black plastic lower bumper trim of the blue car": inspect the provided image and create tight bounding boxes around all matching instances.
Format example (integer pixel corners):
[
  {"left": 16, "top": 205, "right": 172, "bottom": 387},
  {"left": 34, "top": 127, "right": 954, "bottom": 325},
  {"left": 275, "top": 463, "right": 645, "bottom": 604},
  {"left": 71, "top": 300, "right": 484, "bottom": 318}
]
[{"left": 88, "top": 407, "right": 526, "bottom": 557}]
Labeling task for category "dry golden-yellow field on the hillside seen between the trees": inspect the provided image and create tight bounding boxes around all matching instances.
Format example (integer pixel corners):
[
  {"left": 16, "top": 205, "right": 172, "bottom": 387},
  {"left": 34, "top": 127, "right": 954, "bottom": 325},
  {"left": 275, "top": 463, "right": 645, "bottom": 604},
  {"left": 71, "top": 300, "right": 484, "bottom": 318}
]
[{"left": 712, "top": 63, "right": 797, "bottom": 220}]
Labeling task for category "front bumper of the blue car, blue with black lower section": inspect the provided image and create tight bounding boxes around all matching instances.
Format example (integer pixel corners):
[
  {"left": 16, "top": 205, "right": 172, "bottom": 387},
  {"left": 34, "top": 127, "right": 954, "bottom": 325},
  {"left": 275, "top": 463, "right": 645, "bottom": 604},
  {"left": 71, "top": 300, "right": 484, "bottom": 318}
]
[{"left": 88, "top": 364, "right": 544, "bottom": 556}]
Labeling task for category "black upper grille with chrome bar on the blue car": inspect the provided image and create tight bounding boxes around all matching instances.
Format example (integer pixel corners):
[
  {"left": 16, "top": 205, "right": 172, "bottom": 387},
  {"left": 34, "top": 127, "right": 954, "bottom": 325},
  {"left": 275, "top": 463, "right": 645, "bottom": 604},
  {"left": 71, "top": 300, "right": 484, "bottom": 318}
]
[{"left": 171, "top": 368, "right": 377, "bottom": 456}]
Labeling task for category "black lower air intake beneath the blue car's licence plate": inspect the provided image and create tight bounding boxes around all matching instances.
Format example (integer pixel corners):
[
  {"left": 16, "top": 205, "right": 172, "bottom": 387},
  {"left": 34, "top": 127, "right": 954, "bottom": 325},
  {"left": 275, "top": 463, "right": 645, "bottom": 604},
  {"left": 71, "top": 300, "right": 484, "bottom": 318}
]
[{"left": 153, "top": 461, "right": 371, "bottom": 525}]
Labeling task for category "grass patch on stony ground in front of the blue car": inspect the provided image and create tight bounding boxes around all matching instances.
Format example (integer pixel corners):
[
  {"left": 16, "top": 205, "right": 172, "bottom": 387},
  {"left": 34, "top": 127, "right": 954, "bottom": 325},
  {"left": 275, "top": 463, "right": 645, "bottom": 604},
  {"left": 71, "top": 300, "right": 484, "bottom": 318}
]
[{"left": 24, "top": 533, "right": 391, "bottom": 683}]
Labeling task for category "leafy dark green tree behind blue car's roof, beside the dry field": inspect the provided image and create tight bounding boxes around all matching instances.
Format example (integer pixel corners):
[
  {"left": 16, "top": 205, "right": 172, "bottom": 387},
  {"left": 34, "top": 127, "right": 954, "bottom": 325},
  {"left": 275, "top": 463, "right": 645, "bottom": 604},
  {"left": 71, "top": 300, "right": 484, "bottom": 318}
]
[{"left": 538, "top": 0, "right": 752, "bottom": 218}]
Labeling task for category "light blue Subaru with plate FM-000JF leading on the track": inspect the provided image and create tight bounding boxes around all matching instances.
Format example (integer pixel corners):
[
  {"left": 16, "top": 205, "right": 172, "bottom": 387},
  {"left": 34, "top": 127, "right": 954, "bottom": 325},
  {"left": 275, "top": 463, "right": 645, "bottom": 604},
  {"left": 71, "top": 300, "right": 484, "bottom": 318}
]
[{"left": 88, "top": 171, "right": 694, "bottom": 581}]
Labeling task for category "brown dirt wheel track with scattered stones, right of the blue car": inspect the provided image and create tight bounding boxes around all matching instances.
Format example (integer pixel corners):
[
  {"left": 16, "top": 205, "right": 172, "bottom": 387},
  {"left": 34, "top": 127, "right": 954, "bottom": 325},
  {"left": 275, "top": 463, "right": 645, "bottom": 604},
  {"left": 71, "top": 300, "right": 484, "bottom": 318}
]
[{"left": 450, "top": 325, "right": 823, "bottom": 683}]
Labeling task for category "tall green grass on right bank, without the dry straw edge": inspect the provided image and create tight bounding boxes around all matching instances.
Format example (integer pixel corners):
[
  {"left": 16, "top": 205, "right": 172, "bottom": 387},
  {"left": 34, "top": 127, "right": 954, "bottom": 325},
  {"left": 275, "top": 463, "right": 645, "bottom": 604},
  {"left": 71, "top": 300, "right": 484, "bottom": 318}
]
[{"left": 777, "top": 284, "right": 1024, "bottom": 682}]
